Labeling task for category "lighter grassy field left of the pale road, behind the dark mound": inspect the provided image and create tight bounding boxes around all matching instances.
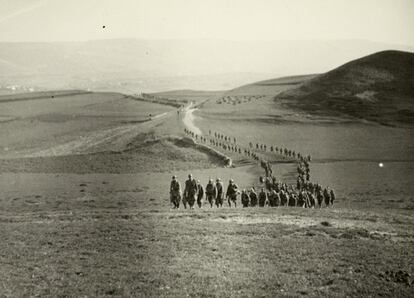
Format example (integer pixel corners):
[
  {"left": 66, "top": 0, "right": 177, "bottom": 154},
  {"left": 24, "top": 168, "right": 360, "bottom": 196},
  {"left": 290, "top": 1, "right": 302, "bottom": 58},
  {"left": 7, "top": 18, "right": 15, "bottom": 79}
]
[{"left": 0, "top": 91, "right": 174, "bottom": 158}]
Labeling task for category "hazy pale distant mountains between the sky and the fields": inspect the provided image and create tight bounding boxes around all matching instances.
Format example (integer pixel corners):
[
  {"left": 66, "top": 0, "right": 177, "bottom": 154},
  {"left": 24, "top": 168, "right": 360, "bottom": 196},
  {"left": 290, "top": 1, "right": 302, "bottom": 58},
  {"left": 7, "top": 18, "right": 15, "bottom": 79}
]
[{"left": 0, "top": 39, "right": 414, "bottom": 93}]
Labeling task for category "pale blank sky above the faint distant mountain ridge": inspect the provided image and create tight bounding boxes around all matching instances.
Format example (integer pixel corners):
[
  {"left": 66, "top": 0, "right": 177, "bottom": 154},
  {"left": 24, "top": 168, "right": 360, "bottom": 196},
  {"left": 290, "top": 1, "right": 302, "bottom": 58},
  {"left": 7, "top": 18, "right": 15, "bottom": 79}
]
[{"left": 0, "top": 0, "right": 414, "bottom": 46}]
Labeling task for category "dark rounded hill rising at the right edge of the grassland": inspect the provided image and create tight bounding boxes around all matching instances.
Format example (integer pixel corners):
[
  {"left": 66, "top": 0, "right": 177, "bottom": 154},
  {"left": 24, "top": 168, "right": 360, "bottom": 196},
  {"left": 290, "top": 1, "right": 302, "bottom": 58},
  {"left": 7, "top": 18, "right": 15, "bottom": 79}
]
[{"left": 276, "top": 51, "right": 414, "bottom": 124}]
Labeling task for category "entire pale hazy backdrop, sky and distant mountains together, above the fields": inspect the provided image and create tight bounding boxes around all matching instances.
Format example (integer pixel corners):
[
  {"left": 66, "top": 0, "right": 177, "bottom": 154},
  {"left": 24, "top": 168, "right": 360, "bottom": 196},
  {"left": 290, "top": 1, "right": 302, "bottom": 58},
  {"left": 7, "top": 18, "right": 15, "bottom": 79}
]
[{"left": 0, "top": 0, "right": 414, "bottom": 92}]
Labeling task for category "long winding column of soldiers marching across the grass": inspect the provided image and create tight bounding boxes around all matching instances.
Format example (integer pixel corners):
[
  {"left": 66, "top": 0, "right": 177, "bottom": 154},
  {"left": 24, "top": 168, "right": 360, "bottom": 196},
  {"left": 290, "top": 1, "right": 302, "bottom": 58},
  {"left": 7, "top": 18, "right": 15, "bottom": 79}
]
[{"left": 170, "top": 129, "right": 335, "bottom": 208}]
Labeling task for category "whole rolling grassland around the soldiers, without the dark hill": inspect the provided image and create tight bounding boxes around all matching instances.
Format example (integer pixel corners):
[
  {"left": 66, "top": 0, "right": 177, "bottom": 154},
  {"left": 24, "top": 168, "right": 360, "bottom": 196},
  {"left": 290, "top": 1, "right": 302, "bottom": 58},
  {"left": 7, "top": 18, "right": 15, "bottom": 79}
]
[{"left": 0, "top": 50, "right": 414, "bottom": 297}]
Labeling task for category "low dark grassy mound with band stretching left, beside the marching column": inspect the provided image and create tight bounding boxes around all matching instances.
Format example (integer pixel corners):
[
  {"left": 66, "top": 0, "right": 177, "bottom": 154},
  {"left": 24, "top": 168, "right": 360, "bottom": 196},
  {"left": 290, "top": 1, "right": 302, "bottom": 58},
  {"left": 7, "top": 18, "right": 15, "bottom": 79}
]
[{"left": 0, "top": 134, "right": 226, "bottom": 174}]
